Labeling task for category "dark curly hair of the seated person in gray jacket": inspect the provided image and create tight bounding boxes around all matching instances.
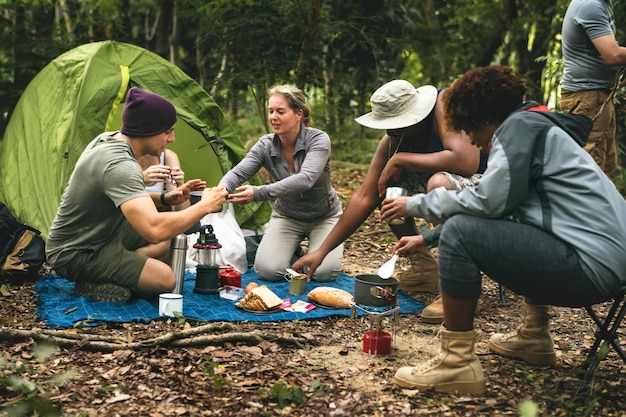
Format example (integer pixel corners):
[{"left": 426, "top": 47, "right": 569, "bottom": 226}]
[{"left": 442, "top": 65, "right": 526, "bottom": 132}]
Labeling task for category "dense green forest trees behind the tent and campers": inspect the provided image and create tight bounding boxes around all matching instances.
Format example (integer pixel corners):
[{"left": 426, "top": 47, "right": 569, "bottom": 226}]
[{"left": 0, "top": 0, "right": 596, "bottom": 141}]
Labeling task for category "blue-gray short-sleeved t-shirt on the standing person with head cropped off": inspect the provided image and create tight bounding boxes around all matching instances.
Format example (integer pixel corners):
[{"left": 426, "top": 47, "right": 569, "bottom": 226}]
[{"left": 561, "top": 0, "right": 617, "bottom": 91}]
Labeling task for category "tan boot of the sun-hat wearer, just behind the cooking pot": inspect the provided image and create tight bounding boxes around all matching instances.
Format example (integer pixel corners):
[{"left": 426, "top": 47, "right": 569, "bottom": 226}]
[{"left": 397, "top": 249, "right": 439, "bottom": 294}]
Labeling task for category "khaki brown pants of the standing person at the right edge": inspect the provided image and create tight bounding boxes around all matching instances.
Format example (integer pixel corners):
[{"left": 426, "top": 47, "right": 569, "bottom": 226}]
[{"left": 561, "top": 89, "right": 618, "bottom": 174}]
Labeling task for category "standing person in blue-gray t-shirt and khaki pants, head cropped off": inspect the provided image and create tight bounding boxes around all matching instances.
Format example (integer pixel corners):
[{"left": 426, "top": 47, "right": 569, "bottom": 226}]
[{"left": 561, "top": 0, "right": 626, "bottom": 174}]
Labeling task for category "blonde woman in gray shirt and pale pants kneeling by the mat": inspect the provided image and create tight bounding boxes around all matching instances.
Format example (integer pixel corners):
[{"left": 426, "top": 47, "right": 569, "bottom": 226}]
[{"left": 219, "top": 85, "right": 343, "bottom": 281}]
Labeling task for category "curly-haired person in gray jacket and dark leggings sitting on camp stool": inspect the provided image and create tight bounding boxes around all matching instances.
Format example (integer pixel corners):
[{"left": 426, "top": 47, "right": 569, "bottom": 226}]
[{"left": 381, "top": 66, "right": 626, "bottom": 393}]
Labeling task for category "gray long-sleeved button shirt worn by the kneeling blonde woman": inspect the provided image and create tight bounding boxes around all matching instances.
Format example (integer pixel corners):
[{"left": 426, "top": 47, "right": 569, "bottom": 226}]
[{"left": 220, "top": 125, "right": 341, "bottom": 221}]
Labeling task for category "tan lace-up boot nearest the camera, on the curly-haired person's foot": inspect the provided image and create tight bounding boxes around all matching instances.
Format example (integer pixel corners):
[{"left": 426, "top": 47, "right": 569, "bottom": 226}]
[{"left": 394, "top": 326, "right": 486, "bottom": 394}]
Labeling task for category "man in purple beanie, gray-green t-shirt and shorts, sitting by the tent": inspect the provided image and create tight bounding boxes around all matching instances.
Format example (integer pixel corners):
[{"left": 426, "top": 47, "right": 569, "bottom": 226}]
[{"left": 46, "top": 87, "right": 227, "bottom": 302}]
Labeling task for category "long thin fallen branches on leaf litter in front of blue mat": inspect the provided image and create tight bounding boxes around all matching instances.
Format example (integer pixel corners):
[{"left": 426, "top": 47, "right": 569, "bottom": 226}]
[{"left": 0, "top": 323, "right": 306, "bottom": 352}]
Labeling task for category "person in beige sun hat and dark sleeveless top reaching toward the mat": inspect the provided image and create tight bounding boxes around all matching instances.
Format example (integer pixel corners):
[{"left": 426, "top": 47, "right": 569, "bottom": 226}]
[{"left": 293, "top": 80, "right": 484, "bottom": 321}]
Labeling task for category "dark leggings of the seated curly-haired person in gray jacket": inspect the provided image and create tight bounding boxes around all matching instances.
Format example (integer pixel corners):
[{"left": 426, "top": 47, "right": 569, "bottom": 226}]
[{"left": 439, "top": 215, "right": 606, "bottom": 307}]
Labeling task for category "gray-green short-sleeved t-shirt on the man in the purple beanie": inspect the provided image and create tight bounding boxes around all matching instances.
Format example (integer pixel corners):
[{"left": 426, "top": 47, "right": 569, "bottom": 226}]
[{"left": 46, "top": 132, "right": 148, "bottom": 265}]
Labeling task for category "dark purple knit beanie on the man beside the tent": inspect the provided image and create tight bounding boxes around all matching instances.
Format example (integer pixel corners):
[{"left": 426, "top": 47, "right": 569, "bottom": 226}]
[{"left": 120, "top": 87, "right": 176, "bottom": 137}]
